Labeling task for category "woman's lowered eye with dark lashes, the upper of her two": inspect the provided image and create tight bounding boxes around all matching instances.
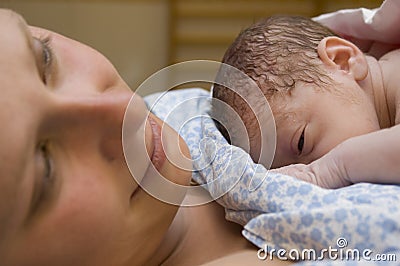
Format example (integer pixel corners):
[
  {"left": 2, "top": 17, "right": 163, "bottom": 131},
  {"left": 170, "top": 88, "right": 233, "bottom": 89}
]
[{"left": 34, "top": 36, "right": 54, "bottom": 84}]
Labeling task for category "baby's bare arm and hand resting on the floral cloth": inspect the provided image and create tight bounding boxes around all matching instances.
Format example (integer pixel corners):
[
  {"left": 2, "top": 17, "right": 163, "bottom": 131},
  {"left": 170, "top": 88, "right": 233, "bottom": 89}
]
[{"left": 274, "top": 125, "right": 400, "bottom": 188}]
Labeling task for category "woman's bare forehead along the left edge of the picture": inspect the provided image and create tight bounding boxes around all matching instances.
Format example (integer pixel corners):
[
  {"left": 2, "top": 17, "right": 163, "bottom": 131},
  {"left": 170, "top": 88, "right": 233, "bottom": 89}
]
[{"left": 0, "top": 9, "right": 38, "bottom": 241}]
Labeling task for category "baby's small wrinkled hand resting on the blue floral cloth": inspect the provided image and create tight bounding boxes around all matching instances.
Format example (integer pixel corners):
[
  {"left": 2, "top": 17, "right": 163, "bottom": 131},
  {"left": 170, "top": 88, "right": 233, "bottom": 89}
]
[{"left": 271, "top": 153, "right": 351, "bottom": 188}]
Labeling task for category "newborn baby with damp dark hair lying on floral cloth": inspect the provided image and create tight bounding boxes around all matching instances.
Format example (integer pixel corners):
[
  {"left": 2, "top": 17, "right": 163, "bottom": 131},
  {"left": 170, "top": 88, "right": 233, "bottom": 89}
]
[{"left": 212, "top": 16, "right": 400, "bottom": 188}]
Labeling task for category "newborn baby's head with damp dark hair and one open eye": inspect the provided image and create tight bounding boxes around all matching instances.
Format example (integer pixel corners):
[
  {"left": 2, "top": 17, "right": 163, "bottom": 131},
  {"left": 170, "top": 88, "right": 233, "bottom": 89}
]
[{"left": 212, "top": 16, "right": 380, "bottom": 167}]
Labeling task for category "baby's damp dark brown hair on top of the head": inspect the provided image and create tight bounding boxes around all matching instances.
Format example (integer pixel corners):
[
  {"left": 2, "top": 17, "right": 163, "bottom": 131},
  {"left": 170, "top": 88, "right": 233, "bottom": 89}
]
[{"left": 211, "top": 16, "right": 336, "bottom": 144}]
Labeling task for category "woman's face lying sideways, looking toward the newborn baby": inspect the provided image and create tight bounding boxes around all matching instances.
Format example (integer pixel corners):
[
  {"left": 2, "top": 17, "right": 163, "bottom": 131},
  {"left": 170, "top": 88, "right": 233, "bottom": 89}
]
[{"left": 0, "top": 10, "right": 190, "bottom": 265}]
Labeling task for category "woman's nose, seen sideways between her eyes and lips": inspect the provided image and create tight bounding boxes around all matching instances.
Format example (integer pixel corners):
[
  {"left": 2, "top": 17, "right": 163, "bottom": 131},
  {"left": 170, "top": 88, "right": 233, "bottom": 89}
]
[{"left": 52, "top": 90, "right": 147, "bottom": 160}]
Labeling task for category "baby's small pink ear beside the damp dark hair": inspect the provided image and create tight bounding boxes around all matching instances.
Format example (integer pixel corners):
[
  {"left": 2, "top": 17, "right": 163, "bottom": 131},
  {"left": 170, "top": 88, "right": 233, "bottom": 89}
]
[{"left": 318, "top": 36, "right": 368, "bottom": 81}]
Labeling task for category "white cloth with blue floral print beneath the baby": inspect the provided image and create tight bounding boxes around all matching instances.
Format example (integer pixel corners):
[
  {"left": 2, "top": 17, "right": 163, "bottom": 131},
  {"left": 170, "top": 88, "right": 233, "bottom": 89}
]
[{"left": 145, "top": 89, "right": 400, "bottom": 265}]
